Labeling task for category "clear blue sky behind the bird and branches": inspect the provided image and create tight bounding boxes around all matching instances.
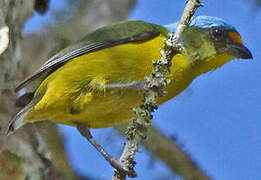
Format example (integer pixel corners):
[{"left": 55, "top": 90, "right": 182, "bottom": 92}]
[{"left": 25, "top": 0, "right": 261, "bottom": 180}]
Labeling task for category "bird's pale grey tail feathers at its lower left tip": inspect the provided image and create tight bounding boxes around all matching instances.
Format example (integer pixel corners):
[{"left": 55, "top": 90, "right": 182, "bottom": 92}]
[{"left": 6, "top": 93, "right": 39, "bottom": 136}]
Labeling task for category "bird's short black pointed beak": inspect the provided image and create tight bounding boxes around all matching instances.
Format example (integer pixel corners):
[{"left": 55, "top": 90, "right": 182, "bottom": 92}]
[{"left": 228, "top": 44, "right": 253, "bottom": 59}]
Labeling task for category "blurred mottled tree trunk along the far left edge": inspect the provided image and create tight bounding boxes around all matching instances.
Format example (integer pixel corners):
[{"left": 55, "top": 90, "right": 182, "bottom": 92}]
[{"left": 0, "top": 0, "right": 40, "bottom": 180}]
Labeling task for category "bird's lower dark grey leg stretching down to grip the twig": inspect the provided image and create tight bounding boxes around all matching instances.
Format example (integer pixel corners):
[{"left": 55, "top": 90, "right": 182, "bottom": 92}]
[{"left": 76, "top": 124, "right": 137, "bottom": 177}]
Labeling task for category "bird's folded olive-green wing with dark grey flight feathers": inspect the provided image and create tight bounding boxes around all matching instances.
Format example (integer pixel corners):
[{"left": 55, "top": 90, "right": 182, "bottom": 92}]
[{"left": 15, "top": 21, "right": 168, "bottom": 91}]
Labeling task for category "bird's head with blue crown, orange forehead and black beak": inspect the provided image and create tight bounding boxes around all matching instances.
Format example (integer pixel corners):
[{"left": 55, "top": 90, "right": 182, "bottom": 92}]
[{"left": 166, "top": 16, "right": 253, "bottom": 74}]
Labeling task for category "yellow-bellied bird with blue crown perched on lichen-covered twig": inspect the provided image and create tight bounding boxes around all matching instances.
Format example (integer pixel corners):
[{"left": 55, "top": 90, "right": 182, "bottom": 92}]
[{"left": 7, "top": 16, "right": 253, "bottom": 176}]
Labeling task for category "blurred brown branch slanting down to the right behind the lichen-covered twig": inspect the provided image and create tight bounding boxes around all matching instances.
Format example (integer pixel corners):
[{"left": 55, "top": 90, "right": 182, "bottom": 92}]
[{"left": 116, "top": 125, "right": 211, "bottom": 180}]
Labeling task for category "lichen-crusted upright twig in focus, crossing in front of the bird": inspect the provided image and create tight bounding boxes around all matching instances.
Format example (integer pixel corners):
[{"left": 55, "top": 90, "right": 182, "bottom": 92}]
[{"left": 112, "top": 0, "right": 202, "bottom": 180}]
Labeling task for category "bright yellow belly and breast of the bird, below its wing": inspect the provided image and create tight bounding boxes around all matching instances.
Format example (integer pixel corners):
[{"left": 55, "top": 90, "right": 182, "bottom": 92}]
[{"left": 24, "top": 36, "right": 194, "bottom": 128}]
